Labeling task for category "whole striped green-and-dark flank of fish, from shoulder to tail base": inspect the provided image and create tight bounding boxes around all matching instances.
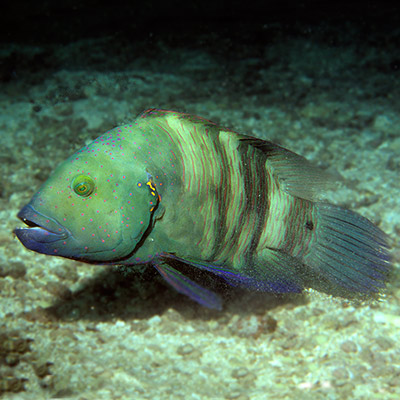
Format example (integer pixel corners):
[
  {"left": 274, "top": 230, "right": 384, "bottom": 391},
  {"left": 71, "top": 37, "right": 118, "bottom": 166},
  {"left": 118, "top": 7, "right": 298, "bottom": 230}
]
[{"left": 142, "top": 112, "right": 315, "bottom": 269}]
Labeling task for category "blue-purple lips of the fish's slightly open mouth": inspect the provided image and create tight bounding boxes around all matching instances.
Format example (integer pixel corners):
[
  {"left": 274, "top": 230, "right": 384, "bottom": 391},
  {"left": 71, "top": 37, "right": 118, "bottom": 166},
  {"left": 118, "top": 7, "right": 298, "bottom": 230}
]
[{"left": 14, "top": 204, "right": 70, "bottom": 254}]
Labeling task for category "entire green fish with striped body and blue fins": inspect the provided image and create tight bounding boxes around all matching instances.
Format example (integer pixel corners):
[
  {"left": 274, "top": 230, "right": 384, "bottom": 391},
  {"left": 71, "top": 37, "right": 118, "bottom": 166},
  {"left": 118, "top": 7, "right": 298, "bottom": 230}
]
[{"left": 14, "top": 108, "right": 391, "bottom": 310}]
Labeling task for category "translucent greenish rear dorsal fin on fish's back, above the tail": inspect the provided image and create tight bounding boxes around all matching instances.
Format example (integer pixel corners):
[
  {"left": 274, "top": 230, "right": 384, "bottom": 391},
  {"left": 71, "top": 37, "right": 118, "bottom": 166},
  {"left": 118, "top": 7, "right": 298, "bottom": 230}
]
[{"left": 240, "top": 137, "right": 339, "bottom": 200}]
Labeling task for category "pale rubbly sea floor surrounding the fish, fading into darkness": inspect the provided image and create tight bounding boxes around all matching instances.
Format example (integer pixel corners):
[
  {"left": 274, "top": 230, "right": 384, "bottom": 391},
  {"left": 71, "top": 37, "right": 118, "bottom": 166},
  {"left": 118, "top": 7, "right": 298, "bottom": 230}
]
[{"left": 0, "top": 14, "right": 400, "bottom": 400}]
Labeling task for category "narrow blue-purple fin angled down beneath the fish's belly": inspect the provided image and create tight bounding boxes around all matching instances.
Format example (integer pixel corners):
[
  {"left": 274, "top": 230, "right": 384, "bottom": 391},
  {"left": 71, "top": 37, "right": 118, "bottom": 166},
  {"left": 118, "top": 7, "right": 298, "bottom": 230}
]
[{"left": 153, "top": 263, "right": 222, "bottom": 310}]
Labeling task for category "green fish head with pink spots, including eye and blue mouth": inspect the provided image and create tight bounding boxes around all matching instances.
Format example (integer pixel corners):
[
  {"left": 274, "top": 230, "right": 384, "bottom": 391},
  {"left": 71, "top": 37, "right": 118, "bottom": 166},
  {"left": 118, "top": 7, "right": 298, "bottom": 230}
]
[{"left": 15, "top": 128, "right": 160, "bottom": 264}]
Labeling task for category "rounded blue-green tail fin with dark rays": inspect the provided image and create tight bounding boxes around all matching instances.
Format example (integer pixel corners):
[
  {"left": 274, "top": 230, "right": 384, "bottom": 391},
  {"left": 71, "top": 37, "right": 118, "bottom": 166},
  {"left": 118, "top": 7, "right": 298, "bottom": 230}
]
[{"left": 304, "top": 203, "right": 391, "bottom": 297}]
